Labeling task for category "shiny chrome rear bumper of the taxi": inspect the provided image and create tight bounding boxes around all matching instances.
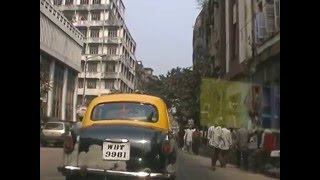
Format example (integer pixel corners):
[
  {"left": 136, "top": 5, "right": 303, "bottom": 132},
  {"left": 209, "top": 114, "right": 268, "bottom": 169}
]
[{"left": 58, "top": 166, "right": 172, "bottom": 178}]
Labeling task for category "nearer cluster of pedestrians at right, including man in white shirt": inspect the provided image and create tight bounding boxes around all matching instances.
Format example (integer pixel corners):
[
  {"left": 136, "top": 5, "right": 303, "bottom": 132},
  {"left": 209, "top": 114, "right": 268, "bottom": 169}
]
[{"left": 207, "top": 126, "right": 276, "bottom": 172}]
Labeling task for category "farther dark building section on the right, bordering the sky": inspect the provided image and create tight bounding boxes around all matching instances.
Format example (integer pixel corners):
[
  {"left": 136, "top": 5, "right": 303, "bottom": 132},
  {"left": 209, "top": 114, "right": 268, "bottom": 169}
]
[{"left": 193, "top": 0, "right": 226, "bottom": 77}]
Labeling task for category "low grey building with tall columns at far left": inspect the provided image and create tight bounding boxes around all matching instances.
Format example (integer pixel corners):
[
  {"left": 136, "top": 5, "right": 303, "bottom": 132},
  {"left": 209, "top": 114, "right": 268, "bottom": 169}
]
[{"left": 40, "top": 0, "right": 83, "bottom": 121}]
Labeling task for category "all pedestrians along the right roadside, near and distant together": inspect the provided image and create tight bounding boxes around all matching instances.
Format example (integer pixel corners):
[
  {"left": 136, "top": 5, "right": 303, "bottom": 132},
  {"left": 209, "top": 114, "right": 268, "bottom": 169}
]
[{"left": 178, "top": 126, "right": 276, "bottom": 171}]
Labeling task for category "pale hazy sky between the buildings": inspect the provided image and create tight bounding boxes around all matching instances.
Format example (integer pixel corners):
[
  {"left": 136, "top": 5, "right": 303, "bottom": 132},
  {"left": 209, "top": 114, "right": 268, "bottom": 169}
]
[{"left": 123, "top": 0, "right": 199, "bottom": 75}]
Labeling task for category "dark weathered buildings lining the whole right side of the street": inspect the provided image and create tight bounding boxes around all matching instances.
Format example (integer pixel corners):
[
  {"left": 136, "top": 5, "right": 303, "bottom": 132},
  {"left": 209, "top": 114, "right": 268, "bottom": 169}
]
[{"left": 193, "top": 0, "right": 280, "bottom": 130}]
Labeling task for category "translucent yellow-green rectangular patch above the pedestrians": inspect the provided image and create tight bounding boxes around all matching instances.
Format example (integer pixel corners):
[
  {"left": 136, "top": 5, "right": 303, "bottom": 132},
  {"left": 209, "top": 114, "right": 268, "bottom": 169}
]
[{"left": 200, "top": 79, "right": 250, "bottom": 127}]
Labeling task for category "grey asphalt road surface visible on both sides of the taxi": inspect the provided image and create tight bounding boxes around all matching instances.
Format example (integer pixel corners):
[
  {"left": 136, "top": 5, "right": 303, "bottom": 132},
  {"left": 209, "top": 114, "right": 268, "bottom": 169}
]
[{"left": 40, "top": 148, "right": 273, "bottom": 180}]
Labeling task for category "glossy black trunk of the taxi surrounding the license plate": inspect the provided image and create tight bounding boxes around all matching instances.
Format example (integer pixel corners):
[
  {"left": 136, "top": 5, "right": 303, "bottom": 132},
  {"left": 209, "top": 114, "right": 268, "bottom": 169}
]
[{"left": 79, "top": 124, "right": 166, "bottom": 172}]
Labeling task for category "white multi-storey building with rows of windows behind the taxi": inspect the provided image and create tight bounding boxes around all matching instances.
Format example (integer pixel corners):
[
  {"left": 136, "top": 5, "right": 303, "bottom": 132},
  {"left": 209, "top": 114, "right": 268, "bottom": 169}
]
[{"left": 51, "top": 0, "right": 136, "bottom": 103}]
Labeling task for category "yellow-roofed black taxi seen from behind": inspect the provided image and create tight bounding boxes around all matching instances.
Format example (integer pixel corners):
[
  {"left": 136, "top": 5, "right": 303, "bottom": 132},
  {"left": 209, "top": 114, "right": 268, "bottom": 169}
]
[{"left": 58, "top": 93, "right": 176, "bottom": 180}]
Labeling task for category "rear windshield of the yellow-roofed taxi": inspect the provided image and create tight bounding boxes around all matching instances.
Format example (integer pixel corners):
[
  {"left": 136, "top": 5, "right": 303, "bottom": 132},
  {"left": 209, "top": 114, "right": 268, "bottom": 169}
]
[{"left": 91, "top": 102, "right": 158, "bottom": 122}]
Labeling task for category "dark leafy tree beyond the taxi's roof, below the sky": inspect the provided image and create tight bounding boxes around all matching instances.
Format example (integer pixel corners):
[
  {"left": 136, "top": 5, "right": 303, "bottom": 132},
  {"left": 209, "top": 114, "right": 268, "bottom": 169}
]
[{"left": 145, "top": 67, "right": 200, "bottom": 124}]
